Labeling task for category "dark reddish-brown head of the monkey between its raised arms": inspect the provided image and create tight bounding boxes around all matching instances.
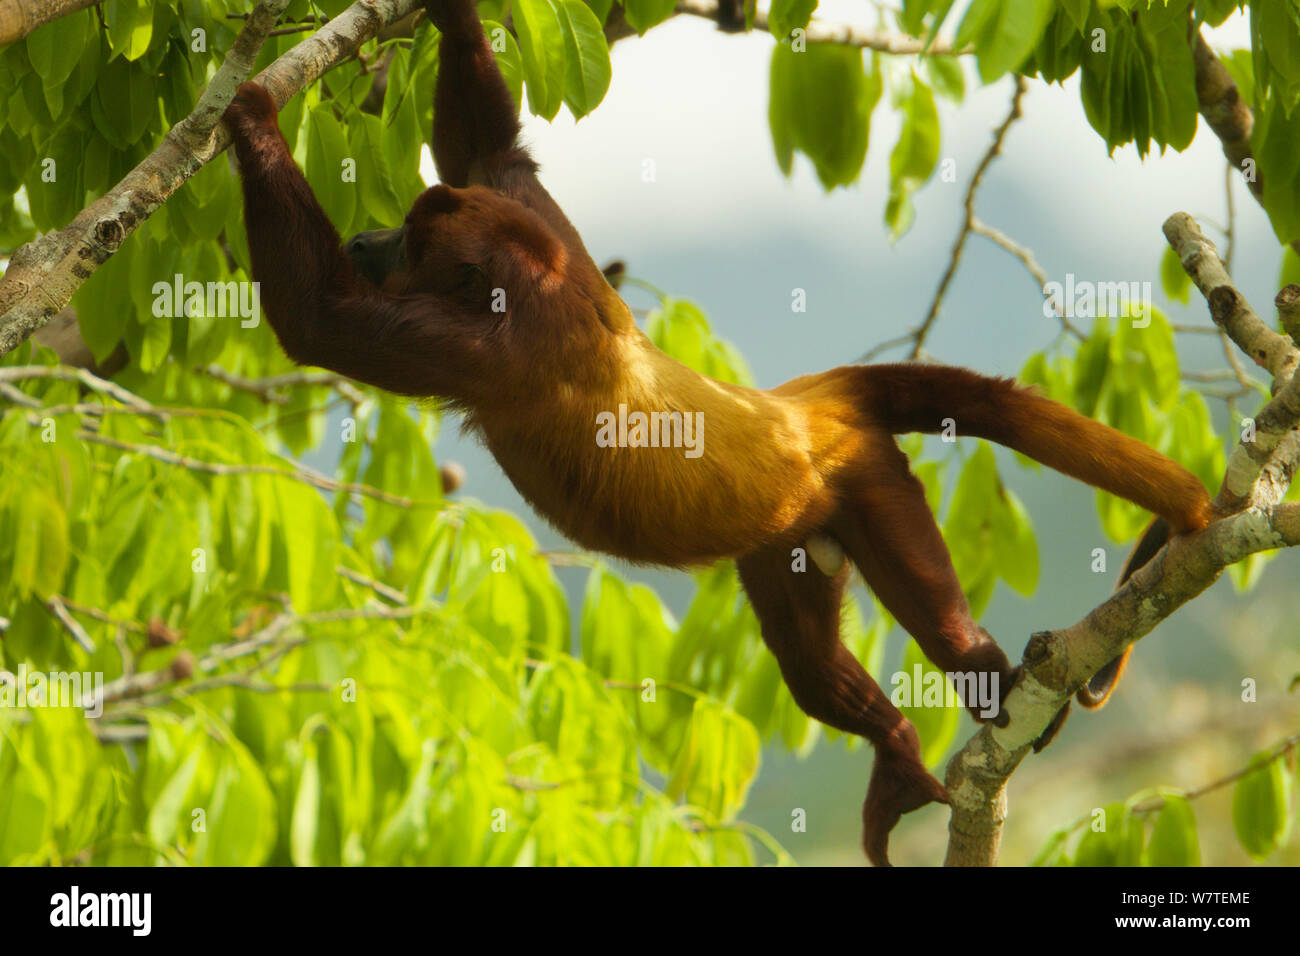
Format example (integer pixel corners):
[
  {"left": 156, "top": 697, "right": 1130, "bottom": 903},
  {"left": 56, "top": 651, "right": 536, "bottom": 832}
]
[{"left": 347, "top": 186, "right": 568, "bottom": 311}]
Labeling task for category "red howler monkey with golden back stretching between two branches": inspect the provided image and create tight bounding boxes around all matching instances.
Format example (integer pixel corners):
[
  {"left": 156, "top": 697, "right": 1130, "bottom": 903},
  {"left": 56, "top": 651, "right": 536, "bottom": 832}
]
[{"left": 225, "top": 0, "right": 1210, "bottom": 864}]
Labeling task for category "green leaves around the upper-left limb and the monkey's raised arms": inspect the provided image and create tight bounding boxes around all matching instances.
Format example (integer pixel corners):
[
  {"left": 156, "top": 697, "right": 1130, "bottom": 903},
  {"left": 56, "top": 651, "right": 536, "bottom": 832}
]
[{"left": 0, "top": 0, "right": 610, "bottom": 372}]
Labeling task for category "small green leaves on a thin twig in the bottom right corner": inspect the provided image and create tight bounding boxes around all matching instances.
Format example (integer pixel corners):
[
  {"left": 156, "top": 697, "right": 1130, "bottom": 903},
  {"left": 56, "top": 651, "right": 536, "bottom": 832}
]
[{"left": 1034, "top": 750, "right": 1296, "bottom": 866}]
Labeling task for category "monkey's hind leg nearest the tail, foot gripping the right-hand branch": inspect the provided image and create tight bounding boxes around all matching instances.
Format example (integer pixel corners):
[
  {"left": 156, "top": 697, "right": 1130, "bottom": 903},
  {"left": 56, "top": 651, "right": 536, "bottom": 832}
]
[{"left": 828, "top": 438, "right": 1015, "bottom": 721}]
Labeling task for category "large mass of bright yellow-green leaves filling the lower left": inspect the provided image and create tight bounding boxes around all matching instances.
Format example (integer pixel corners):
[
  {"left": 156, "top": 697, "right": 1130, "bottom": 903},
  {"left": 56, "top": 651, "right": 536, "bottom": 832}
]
[{"left": 0, "top": 323, "right": 790, "bottom": 865}]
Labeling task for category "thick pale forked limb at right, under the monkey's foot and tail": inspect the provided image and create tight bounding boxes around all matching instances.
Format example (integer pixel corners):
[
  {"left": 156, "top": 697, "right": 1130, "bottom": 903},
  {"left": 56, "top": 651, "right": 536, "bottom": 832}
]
[{"left": 945, "top": 213, "right": 1300, "bottom": 866}]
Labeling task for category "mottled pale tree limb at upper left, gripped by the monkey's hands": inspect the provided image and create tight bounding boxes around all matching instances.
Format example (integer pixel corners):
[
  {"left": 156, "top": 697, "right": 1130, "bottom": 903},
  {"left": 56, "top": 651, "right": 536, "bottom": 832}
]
[{"left": 0, "top": 0, "right": 419, "bottom": 355}]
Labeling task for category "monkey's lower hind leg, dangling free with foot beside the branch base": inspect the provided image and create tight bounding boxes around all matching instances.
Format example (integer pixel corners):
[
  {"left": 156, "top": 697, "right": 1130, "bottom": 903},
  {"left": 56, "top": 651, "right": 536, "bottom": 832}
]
[{"left": 737, "top": 546, "right": 948, "bottom": 866}]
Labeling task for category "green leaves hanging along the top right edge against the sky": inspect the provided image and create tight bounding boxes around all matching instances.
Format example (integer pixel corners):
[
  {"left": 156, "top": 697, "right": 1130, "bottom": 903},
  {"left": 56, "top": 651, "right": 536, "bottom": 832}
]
[{"left": 768, "top": 0, "right": 1300, "bottom": 251}]
